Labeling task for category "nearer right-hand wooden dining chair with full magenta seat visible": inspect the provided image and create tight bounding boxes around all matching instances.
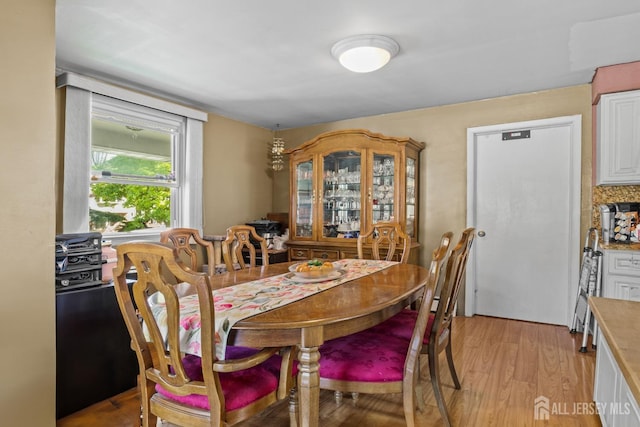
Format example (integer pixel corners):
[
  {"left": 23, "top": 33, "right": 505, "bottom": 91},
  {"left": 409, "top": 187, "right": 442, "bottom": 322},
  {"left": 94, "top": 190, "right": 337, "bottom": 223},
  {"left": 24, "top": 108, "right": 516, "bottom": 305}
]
[{"left": 319, "top": 232, "right": 449, "bottom": 427}]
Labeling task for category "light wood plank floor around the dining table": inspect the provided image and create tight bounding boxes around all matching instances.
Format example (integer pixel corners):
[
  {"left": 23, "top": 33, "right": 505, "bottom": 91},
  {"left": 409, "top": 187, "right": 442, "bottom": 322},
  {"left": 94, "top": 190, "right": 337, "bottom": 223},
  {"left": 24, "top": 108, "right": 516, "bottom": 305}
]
[{"left": 57, "top": 316, "right": 601, "bottom": 427}]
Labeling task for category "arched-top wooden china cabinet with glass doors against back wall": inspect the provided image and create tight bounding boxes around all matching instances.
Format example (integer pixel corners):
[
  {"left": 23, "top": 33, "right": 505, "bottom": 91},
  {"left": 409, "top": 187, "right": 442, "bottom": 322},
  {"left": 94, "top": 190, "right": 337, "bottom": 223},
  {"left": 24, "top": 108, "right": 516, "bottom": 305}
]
[{"left": 285, "top": 129, "right": 425, "bottom": 262}]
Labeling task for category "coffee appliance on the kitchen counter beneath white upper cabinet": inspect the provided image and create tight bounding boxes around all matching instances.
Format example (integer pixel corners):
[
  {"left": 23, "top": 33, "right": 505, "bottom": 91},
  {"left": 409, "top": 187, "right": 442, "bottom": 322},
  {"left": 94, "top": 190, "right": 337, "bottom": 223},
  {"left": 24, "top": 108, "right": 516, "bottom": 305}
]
[{"left": 600, "top": 202, "right": 640, "bottom": 243}]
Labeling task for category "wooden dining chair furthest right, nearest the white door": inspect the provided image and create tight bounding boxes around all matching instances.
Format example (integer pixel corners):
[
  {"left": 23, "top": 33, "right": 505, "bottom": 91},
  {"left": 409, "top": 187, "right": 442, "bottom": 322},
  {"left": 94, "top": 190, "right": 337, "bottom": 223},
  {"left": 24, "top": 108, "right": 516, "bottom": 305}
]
[{"left": 371, "top": 227, "right": 475, "bottom": 426}]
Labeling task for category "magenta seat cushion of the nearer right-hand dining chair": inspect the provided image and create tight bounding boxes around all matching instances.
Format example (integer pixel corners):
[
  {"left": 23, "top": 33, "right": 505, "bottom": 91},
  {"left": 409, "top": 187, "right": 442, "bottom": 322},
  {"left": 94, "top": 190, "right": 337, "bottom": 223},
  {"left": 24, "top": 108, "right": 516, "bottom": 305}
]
[{"left": 320, "top": 330, "right": 409, "bottom": 382}]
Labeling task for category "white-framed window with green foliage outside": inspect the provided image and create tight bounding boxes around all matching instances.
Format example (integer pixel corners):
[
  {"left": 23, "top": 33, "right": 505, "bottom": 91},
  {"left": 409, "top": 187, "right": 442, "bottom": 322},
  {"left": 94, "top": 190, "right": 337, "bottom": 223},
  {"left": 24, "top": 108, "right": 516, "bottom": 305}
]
[{"left": 59, "top": 74, "right": 206, "bottom": 243}]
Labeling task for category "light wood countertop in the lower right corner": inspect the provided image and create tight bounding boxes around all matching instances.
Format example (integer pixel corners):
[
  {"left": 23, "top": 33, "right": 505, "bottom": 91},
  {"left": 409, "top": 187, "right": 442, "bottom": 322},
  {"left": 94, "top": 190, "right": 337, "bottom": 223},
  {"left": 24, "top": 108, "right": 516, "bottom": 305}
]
[{"left": 589, "top": 297, "right": 640, "bottom": 402}]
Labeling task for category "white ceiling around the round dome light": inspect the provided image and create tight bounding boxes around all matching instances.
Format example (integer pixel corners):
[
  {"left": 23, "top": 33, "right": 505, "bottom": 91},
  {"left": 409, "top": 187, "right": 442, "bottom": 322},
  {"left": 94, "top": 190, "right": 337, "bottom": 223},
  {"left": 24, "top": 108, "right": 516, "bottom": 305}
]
[{"left": 56, "top": 0, "right": 640, "bottom": 129}]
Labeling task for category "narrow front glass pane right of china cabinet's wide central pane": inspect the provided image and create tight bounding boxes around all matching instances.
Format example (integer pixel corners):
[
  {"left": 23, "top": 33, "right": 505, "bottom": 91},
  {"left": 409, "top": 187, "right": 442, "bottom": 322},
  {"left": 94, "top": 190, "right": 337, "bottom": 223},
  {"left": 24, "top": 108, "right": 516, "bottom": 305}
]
[{"left": 371, "top": 153, "right": 397, "bottom": 224}]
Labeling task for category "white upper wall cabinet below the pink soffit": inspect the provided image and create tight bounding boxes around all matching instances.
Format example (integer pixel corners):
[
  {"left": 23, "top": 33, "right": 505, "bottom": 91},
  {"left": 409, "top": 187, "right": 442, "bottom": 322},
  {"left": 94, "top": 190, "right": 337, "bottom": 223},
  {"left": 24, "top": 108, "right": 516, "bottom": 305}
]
[{"left": 596, "top": 90, "right": 640, "bottom": 185}]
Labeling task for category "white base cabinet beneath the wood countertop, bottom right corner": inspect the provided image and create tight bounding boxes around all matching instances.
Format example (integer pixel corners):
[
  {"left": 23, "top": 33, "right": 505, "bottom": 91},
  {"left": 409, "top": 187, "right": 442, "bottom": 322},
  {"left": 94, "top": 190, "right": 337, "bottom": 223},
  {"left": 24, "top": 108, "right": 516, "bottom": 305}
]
[{"left": 593, "top": 334, "right": 640, "bottom": 427}]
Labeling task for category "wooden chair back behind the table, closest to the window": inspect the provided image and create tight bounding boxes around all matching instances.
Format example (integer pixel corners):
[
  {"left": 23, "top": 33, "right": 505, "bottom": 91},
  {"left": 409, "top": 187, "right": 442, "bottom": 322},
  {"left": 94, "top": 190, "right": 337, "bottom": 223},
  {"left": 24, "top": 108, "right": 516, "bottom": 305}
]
[{"left": 160, "top": 228, "right": 216, "bottom": 275}]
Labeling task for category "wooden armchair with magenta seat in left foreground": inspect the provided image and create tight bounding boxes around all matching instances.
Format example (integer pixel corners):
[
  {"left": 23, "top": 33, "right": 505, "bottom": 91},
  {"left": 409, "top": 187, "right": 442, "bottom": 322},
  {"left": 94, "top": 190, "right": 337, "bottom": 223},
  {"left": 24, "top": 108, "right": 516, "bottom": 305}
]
[{"left": 114, "top": 242, "right": 296, "bottom": 427}]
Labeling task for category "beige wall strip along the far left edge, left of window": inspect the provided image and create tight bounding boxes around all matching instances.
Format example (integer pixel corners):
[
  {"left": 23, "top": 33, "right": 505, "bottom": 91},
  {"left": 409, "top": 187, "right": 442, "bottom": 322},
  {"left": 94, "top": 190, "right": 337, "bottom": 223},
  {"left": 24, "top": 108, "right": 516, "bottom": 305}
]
[{"left": 0, "top": 0, "right": 56, "bottom": 426}]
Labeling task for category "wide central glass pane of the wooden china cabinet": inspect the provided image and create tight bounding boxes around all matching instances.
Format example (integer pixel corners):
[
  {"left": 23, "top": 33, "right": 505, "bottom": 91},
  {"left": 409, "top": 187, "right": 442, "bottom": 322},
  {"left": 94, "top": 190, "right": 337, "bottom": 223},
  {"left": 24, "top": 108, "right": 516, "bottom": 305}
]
[{"left": 322, "top": 150, "right": 362, "bottom": 238}]
